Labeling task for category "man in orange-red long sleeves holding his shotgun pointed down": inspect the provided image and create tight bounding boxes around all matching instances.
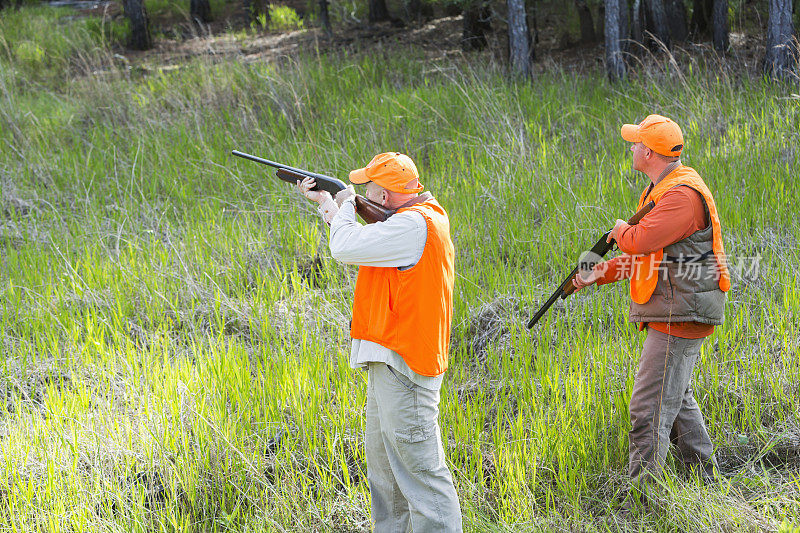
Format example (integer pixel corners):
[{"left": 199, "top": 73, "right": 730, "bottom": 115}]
[{"left": 574, "top": 115, "right": 730, "bottom": 492}]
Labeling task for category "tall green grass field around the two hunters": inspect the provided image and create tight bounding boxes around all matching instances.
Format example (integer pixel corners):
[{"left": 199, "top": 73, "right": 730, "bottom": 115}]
[{"left": 0, "top": 8, "right": 800, "bottom": 532}]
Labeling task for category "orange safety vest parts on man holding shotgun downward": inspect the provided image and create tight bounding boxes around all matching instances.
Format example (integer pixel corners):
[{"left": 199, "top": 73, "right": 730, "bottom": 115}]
[{"left": 631, "top": 166, "right": 731, "bottom": 304}]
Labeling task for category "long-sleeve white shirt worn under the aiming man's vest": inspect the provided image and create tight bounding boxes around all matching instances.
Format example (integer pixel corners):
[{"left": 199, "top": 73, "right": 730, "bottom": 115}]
[{"left": 320, "top": 193, "right": 443, "bottom": 390}]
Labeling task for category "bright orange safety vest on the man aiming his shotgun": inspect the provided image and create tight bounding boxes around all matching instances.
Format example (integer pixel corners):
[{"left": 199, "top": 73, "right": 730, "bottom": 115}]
[{"left": 350, "top": 198, "right": 455, "bottom": 376}]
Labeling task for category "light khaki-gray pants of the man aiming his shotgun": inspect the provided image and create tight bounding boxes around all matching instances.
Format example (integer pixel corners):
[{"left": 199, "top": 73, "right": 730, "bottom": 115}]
[{"left": 364, "top": 363, "right": 462, "bottom": 533}]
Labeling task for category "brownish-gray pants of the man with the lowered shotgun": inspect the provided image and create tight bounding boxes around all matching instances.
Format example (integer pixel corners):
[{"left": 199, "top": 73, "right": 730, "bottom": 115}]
[{"left": 628, "top": 329, "right": 716, "bottom": 483}]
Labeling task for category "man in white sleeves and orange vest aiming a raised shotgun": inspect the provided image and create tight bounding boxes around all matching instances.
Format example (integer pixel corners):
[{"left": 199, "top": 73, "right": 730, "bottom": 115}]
[{"left": 298, "top": 152, "right": 462, "bottom": 532}]
